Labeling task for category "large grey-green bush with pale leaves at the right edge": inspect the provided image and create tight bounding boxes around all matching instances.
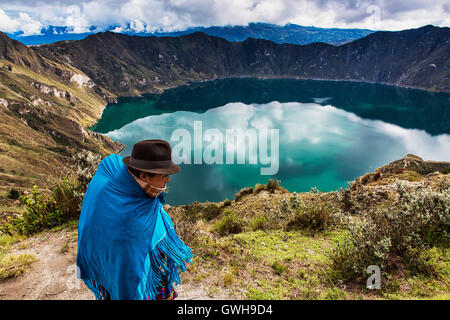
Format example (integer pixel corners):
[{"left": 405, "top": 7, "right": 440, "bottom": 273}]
[{"left": 331, "top": 184, "right": 450, "bottom": 280}]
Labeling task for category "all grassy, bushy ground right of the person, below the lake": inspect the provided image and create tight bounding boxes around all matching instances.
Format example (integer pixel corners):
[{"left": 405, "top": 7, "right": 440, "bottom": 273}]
[{"left": 169, "top": 175, "right": 450, "bottom": 300}]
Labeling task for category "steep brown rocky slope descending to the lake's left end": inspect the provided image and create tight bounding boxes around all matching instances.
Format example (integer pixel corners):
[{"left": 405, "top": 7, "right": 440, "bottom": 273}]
[{"left": 0, "top": 33, "right": 121, "bottom": 195}]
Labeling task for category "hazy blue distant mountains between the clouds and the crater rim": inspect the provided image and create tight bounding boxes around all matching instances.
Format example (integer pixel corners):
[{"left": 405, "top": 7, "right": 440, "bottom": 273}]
[{"left": 8, "top": 23, "right": 374, "bottom": 45}]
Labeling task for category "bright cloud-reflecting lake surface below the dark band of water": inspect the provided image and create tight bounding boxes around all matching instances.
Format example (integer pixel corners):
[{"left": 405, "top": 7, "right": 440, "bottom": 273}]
[{"left": 106, "top": 101, "right": 450, "bottom": 204}]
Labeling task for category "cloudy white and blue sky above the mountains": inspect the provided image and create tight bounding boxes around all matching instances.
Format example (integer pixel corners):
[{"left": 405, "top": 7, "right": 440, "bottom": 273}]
[{"left": 0, "top": 0, "right": 450, "bottom": 35}]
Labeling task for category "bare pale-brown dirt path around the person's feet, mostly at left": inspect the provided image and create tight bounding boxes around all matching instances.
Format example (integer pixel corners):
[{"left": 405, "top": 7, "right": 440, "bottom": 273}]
[{"left": 0, "top": 230, "right": 229, "bottom": 300}]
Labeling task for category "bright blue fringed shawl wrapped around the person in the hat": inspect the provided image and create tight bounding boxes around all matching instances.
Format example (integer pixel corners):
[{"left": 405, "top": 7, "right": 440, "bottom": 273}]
[{"left": 77, "top": 154, "right": 193, "bottom": 300}]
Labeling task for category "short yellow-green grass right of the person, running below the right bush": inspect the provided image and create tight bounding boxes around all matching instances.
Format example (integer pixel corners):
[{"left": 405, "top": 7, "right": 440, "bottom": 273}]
[{"left": 183, "top": 225, "right": 450, "bottom": 300}]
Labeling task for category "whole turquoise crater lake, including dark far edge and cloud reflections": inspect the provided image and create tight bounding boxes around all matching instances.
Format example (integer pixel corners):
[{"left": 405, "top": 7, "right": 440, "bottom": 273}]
[{"left": 93, "top": 79, "right": 450, "bottom": 205}]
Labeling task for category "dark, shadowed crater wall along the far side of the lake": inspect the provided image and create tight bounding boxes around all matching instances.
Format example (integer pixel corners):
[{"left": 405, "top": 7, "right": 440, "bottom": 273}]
[{"left": 33, "top": 26, "right": 450, "bottom": 96}]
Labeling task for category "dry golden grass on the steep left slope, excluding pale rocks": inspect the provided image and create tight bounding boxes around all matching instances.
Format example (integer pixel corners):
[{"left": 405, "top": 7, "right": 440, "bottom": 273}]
[{"left": 0, "top": 59, "right": 119, "bottom": 199}]
